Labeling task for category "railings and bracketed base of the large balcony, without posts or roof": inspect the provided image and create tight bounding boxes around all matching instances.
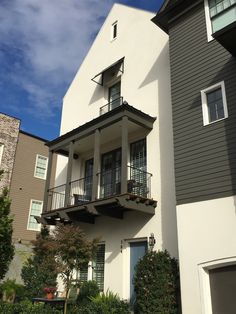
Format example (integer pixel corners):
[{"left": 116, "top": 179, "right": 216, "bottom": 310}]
[{"left": 44, "top": 166, "right": 156, "bottom": 224}]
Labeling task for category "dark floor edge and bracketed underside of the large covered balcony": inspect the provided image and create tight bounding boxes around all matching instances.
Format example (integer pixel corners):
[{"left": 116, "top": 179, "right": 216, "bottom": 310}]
[{"left": 39, "top": 193, "right": 157, "bottom": 225}]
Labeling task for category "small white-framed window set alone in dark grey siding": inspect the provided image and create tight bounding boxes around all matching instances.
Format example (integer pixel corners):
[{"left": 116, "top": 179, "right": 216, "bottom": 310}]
[{"left": 201, "top": 81, "right": 228, "bottom": 125}]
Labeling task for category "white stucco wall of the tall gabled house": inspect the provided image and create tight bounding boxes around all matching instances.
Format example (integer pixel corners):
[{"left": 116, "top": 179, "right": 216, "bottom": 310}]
[{"left": 56, "top": 4, "right": 178, "bottom": 298}]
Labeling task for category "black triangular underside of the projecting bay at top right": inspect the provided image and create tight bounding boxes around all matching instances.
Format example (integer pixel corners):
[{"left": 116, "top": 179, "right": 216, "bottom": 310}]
[{"left": 212, "top": 21, "right": 236, "bottom": 57}]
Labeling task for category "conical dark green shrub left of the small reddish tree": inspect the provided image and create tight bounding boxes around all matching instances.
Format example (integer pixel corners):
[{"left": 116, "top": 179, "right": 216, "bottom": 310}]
[{"left": 21, "top": 227, "right": 58, "bottom": 298}]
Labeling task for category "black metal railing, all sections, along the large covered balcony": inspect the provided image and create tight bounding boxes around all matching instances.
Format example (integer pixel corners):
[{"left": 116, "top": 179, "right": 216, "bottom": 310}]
[{"left": 47, "top": 166, "right": 152, "bottom": 211}]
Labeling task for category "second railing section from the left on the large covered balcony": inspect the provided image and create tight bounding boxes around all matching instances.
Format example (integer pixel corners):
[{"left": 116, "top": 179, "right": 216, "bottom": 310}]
[{"left": 70, "top": 176, "right": 93, "bottom": 205}]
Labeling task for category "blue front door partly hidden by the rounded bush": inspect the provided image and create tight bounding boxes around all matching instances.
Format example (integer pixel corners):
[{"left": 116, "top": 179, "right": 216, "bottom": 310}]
[{"left": 130, "top": 241, "right": 147, "bottom": 304}]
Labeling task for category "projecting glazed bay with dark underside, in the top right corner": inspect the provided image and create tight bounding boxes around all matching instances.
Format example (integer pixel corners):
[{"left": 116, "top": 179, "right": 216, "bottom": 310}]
[{"left": 210, "top": 0, "right": 236, "bottom": 56}]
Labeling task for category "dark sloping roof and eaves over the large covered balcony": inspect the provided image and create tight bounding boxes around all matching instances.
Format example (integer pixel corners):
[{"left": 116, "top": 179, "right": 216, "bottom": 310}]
[{"left": 46, "top": 103, "right": 156, "bottom": 156}]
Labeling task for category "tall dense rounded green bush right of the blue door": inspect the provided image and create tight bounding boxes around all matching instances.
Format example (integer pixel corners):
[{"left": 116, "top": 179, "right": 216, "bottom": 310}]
[{"left": 134, "top": 251, "right": 179, "bottom": 314}]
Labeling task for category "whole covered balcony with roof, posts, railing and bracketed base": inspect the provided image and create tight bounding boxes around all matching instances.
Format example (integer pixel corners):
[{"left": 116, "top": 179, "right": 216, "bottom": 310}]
[{"left": 38, "top": 100, "right": 157, "bottom": 225}]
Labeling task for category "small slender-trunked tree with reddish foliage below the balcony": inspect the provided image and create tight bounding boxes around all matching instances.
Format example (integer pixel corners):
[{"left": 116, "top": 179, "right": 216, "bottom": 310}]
[{"left": 51, "top": 224, "right": 98, "bottom": 313}]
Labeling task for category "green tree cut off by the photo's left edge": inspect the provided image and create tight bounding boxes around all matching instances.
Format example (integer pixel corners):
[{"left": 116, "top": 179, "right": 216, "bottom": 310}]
[{"left": 0, "top": 171, "right": 14, "bottom": 280}]
